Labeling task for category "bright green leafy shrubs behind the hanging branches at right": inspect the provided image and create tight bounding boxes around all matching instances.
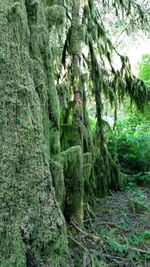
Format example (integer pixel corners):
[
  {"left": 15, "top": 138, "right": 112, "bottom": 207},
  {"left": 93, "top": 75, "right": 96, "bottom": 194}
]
[{"left": 109, "top": 113, "right": 150, "bottom": 171}]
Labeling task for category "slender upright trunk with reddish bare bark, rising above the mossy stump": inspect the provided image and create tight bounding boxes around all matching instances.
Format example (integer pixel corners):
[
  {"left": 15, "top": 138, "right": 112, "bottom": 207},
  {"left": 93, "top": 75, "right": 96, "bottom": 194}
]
[{"left": 70, "top": 0, "right": 83, "bottom": 149}]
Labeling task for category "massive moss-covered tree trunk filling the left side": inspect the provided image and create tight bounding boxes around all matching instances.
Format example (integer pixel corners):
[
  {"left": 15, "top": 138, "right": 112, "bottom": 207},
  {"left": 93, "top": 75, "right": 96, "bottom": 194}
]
[{"left": 0, "top": 0, "right": 71, "bottom": 267}]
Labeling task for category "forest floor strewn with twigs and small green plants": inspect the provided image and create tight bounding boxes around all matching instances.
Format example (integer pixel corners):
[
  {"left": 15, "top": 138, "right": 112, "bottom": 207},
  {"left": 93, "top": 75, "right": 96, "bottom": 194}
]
[{"left": 69, "top": 183, "right": 150, "bottom": 267}]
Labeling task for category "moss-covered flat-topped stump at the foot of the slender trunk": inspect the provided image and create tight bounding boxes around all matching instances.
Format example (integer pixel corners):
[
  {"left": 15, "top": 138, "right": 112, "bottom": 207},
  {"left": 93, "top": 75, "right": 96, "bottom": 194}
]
[{"left": 61, "top": 146, "right": 84, "bottom": 225}]
